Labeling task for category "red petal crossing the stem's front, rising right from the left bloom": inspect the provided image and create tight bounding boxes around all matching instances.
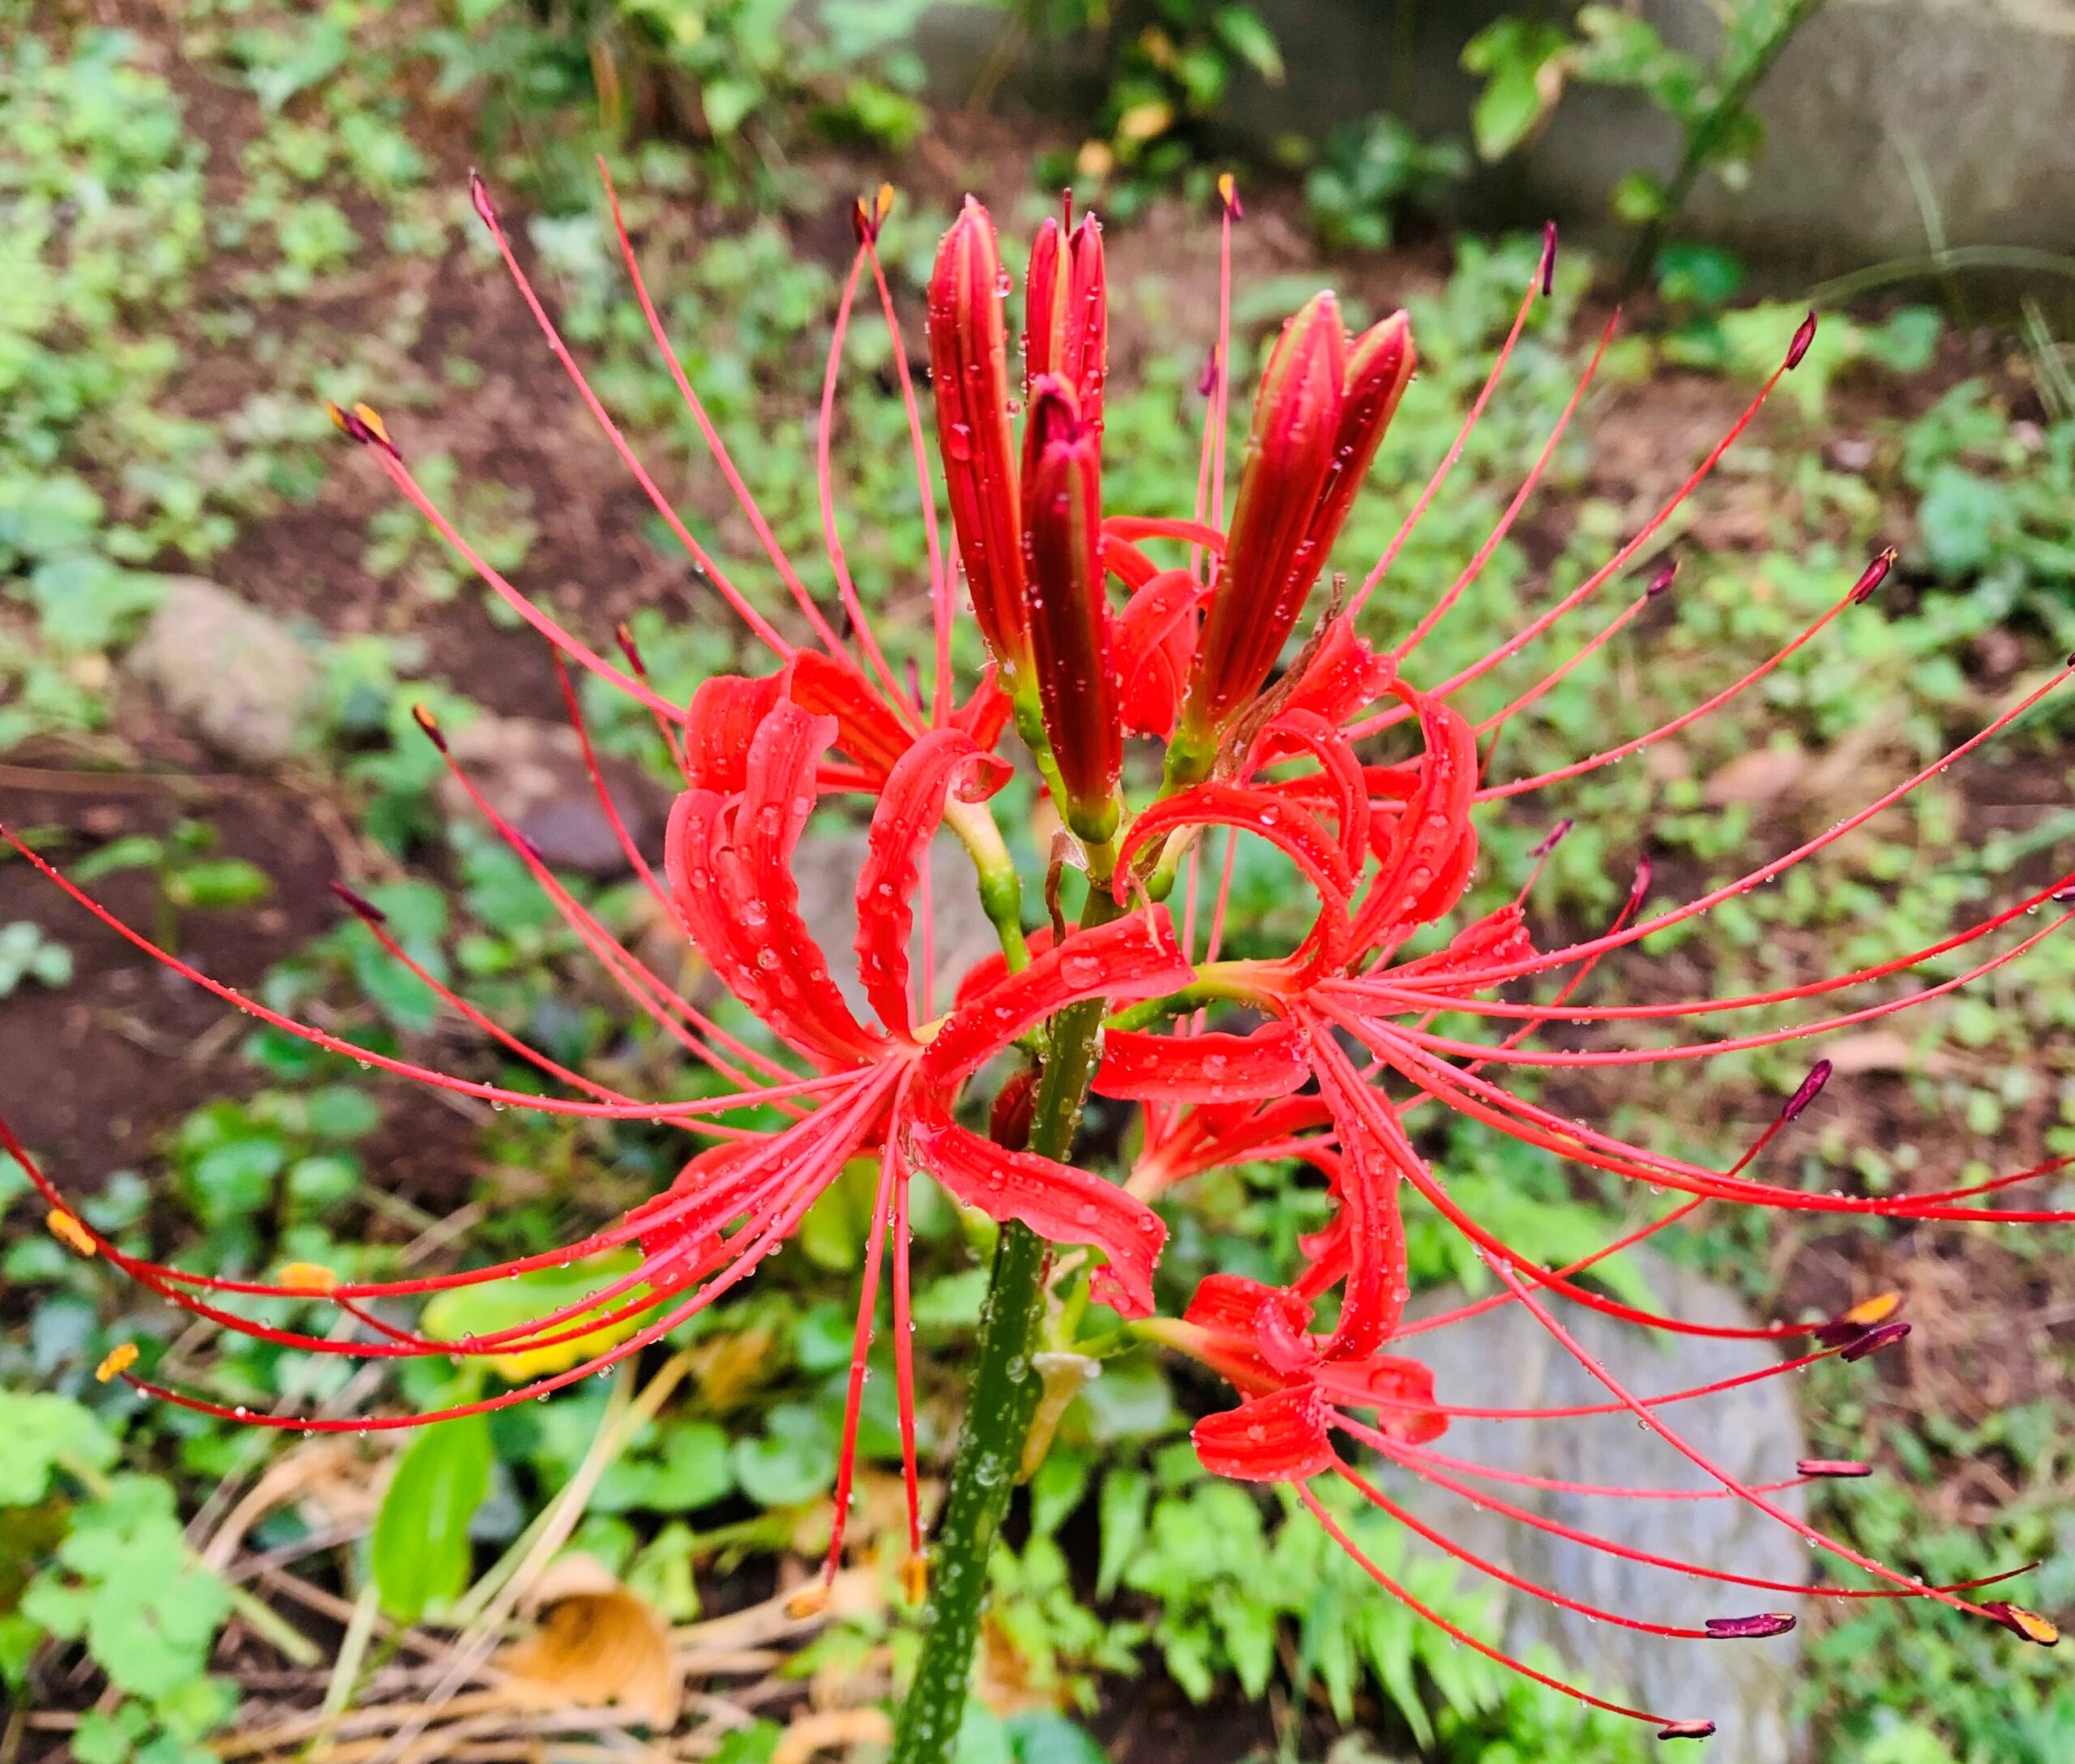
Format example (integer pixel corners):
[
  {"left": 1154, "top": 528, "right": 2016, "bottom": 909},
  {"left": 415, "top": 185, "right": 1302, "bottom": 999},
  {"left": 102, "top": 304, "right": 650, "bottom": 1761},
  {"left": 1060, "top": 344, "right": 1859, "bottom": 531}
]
[{"left": 922, "top": 909, "right": 1196, "bottom": 1094}]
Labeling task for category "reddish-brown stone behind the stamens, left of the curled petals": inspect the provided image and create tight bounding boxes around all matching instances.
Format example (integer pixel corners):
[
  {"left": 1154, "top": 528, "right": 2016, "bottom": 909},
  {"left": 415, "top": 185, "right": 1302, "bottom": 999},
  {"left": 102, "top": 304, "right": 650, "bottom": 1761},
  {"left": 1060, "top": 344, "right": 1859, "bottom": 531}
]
[{"left": 440, "top": 716, "right": 670, "bottom": 876}]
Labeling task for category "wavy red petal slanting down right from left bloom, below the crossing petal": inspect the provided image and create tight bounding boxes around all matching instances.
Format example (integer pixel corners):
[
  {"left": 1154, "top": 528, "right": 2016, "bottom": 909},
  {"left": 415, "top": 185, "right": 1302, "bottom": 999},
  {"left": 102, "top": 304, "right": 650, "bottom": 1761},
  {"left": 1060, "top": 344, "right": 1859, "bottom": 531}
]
[{"left": 909, "top": 1108, "right": 1166, "bottom": 1318}]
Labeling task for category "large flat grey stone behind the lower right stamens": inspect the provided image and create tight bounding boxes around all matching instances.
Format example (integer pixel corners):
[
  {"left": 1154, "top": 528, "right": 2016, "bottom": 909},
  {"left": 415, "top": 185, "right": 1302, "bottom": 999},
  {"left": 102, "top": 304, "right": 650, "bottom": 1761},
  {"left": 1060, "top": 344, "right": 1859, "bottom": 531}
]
[{"left": 1393, "top": 1257, "right": 1812, "bottom": 1764}]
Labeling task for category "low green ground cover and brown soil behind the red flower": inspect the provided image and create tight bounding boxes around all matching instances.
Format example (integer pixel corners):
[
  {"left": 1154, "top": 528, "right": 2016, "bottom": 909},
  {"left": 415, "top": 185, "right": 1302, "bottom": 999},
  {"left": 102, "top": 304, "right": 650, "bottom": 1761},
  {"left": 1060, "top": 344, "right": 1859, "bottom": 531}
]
[{"left": 0, "top": 0, "right": 2075, "bottom": 1764}]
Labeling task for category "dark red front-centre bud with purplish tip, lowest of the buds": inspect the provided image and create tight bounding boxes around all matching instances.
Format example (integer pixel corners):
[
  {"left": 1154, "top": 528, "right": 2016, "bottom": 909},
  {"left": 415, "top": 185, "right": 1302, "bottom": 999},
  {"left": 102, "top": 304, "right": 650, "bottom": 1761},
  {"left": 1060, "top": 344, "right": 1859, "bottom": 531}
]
[{"left": 1023, "top": 375, "right": 1125, "bottom": 845}]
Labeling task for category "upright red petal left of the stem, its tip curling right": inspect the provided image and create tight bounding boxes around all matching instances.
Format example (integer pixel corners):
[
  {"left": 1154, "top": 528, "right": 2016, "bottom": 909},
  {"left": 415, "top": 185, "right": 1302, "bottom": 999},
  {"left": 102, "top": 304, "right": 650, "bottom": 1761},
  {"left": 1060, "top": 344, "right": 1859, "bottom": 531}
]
[{"left": 857, "top": 729, "right": 1015, "bottom": 1035}]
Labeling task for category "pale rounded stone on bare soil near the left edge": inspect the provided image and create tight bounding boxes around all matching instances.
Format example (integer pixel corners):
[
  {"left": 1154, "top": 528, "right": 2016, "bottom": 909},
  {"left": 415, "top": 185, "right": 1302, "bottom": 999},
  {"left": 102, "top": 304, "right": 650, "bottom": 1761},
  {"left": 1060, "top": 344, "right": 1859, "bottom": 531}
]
[{"left": 125, "top": 575, "right": 315, "bottom": 766}]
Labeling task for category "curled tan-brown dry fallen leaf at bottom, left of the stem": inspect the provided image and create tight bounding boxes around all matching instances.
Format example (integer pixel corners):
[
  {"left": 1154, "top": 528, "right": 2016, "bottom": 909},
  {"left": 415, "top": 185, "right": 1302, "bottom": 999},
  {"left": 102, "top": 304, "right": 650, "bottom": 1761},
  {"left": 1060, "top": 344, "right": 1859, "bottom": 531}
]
[{"left": 498, "top": 1559, "right": 678, "bottom": 1731}]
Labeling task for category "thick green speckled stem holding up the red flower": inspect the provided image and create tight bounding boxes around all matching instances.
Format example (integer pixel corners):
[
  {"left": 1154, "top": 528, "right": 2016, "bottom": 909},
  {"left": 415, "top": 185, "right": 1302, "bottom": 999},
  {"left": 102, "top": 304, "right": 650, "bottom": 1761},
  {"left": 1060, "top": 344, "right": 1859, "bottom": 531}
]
[{"left": 892, "top": 888, "right": 1120, "bottom": 1764}]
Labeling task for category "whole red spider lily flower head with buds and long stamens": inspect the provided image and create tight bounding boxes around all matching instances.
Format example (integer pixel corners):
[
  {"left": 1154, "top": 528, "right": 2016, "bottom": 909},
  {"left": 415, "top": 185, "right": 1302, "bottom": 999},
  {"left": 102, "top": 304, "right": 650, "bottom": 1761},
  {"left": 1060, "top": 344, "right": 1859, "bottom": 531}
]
[{"left": 0, "top": 172, "right": 2075, "bottom": 1737}]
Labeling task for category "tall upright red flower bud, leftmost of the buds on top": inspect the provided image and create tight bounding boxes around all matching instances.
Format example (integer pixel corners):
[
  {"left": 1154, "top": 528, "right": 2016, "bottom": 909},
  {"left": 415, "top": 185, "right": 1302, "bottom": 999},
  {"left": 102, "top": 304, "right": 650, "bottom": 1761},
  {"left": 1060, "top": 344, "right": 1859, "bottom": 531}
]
[{"left": 930, "top": 197, "right": 1029, "bottom": 693}]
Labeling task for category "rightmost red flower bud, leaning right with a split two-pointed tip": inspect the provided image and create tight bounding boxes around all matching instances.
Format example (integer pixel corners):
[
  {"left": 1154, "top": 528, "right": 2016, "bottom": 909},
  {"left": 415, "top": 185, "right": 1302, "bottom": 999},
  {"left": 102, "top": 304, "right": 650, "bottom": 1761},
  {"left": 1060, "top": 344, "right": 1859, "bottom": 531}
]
[{"left": 1183, "top": 295, "right": 1413, "bottom": 764}]
